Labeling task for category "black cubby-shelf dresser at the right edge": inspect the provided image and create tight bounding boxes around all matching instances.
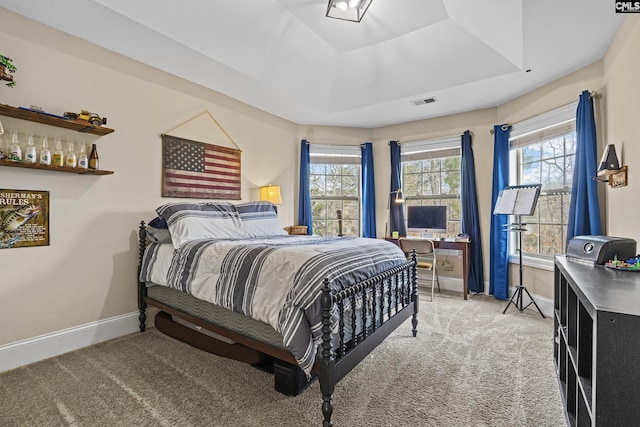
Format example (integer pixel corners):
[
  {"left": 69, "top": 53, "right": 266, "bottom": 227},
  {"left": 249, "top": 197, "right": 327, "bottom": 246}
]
[{"left": 554, "top": 256, "right": 640, "bottom": 426}]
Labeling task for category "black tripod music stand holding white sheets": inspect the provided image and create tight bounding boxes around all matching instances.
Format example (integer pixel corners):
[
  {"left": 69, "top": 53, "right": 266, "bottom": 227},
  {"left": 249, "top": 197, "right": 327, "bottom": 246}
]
[{"left": 493, "top": 184, "right": 545, "bottom": 318}]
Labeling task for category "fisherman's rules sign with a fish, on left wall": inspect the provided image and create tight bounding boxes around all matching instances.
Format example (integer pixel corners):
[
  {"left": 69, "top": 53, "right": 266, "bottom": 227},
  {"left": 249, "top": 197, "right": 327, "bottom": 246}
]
[{"left": 0, "top": 189, "right": 49, "bottom": 249}]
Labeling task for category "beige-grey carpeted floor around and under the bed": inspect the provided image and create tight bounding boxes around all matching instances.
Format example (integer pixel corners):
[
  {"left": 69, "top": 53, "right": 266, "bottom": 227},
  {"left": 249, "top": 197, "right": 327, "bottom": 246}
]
[{"left": 0, "top": 293, "right": 566, "bottom": 427}]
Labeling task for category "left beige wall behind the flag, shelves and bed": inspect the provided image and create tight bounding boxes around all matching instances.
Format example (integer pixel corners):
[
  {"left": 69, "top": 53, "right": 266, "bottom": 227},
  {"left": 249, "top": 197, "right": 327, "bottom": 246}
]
[{"left": 0, "top": 9, "right": 298, "bottom": 345}]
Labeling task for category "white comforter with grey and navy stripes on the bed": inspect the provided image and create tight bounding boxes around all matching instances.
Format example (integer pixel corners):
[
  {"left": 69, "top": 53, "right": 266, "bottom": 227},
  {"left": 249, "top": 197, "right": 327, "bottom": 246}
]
[{"left": 140, "top": 236, "right": 406, "bottom": 374}]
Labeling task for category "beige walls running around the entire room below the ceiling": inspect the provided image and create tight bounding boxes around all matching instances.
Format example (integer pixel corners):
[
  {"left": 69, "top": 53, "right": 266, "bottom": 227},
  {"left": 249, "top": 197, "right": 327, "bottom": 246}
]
[{"left": 0, "top": 9, "right": 640, "bottom": 345}]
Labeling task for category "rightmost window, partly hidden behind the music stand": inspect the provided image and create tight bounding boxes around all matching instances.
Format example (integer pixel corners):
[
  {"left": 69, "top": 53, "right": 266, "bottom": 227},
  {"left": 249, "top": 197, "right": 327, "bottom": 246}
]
[{"left": 509, "top": 104, "right": 576, "bottom": 259}]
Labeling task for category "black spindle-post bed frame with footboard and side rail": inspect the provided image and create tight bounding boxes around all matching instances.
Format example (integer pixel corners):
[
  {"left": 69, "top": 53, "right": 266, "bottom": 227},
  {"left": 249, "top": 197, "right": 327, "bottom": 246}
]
[{"left": 138, "top": 222, "right": 418, "bottom": 427}]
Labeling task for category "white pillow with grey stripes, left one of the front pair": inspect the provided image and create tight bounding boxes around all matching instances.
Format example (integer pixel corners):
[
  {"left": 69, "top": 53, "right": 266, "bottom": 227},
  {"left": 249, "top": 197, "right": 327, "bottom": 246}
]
[{"left": 156, "top": 202, "right": 244, "bottom": 249}]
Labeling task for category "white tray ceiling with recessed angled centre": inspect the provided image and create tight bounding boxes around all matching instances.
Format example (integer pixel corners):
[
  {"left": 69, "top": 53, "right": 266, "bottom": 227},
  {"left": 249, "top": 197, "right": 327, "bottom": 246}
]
[{"left": 0, "top": 0, "right": 624, "bottom": 127}]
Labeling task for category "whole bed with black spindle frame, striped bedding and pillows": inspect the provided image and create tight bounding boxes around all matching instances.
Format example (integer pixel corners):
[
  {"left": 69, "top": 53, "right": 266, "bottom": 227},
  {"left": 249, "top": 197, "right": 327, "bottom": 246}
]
[{"left": 138, "top": 202, "right": 418, "bottom": 426}]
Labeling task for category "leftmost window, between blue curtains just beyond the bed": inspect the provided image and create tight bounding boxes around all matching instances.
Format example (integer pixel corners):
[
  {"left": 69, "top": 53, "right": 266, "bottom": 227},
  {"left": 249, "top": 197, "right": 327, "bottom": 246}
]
[{"left": 309, "top": 144, "right": 361, "bottom": 236}]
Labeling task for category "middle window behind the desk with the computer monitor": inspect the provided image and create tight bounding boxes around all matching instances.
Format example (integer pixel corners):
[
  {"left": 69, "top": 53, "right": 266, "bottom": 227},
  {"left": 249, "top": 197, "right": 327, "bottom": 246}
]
[{"left": 401, "top": 136, "right": 462, "bottom": 237}]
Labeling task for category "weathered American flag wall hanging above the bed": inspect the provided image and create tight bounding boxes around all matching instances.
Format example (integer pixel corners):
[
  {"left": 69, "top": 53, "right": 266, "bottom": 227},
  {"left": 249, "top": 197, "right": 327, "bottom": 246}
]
[{"left": 162, "top": 134, "right": 242, "bottom": 200}]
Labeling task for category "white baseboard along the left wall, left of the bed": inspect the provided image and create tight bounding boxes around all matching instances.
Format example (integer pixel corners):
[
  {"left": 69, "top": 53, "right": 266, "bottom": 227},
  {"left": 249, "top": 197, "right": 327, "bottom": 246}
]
[{"left": 0, "top": 312, "right": 153, "bottom": 372}]
